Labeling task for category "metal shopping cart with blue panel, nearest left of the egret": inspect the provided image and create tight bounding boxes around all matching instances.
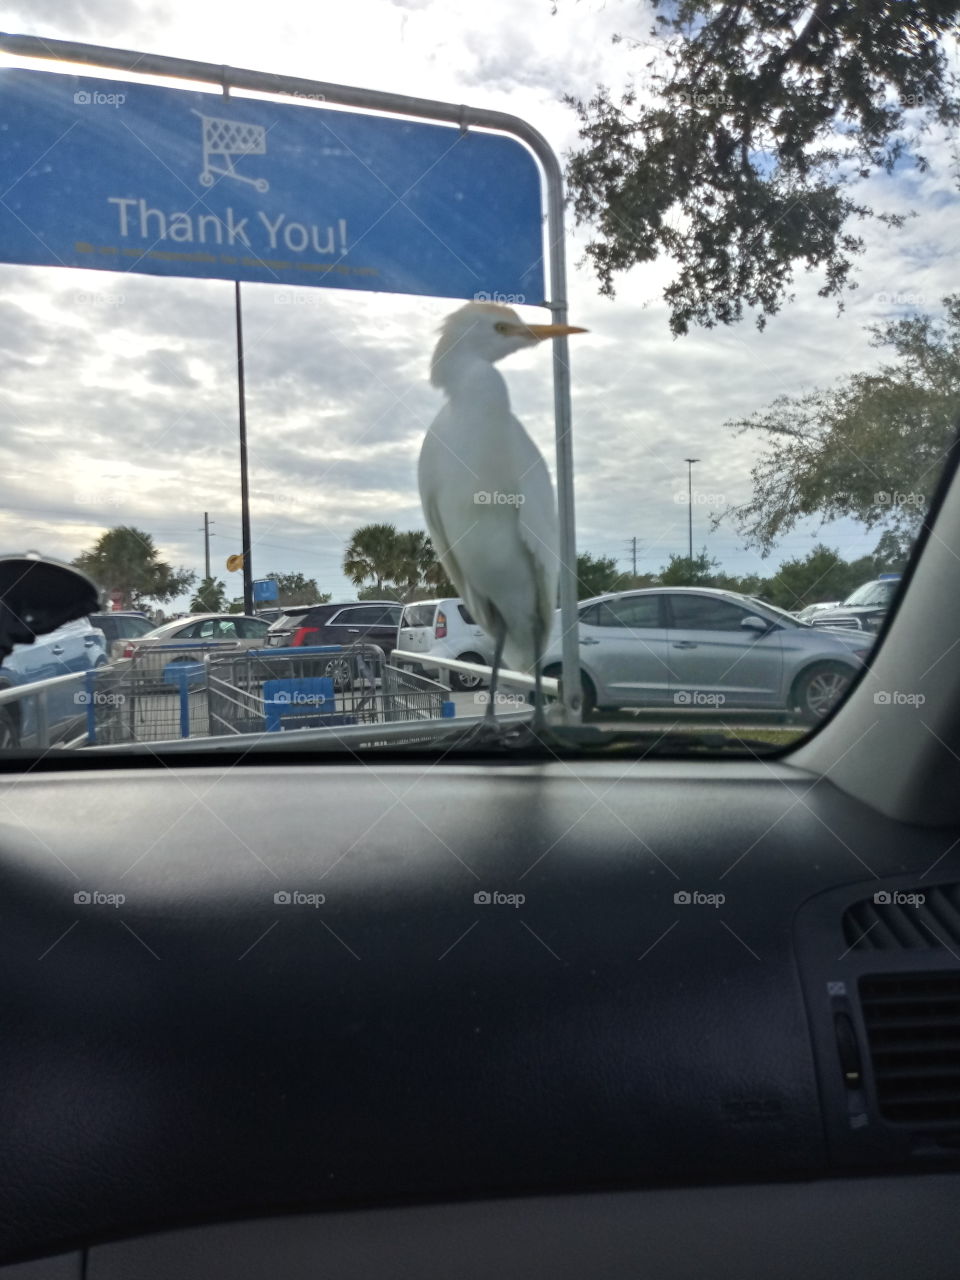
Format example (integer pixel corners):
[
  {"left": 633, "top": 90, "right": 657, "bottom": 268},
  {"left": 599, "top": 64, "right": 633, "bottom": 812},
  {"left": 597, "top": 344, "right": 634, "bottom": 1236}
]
[{"left": 206, "top": 644, "right": 453, "bottom": 736}]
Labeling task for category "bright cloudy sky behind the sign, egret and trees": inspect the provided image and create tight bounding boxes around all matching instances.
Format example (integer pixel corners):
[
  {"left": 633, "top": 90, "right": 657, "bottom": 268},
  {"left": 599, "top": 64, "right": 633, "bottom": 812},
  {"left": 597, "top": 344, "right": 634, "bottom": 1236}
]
[{"left": 0, "top": 0, "right": 960, "bottom": 596}]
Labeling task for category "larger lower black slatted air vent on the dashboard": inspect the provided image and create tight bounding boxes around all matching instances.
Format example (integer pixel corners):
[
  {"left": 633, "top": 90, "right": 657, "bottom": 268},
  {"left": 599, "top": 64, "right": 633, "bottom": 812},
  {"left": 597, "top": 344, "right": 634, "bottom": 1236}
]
[{"left": 860, "top": 973, "right": 960, "bottom": 1125}]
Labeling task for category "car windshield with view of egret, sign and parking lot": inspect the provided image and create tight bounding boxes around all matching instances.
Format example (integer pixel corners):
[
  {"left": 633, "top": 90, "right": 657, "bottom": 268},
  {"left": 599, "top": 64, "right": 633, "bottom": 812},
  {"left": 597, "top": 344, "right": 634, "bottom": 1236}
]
[{"left": 0, "top": 0, "right": 960, "bottom": 758}]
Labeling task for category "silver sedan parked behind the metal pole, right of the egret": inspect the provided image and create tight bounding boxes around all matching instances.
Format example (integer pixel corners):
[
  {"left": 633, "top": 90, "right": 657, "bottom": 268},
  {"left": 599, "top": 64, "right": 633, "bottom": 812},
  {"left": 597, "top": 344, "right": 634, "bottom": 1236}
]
[{"left": 544, "top": 586, "right": 869, "bottom": 722}]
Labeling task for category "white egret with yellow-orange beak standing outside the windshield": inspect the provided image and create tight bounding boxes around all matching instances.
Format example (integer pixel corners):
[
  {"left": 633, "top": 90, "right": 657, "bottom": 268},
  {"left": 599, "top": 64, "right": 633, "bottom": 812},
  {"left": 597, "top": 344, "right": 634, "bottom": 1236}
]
[{"left": 419, "top": 302, "right": 586, "bottom": 727}]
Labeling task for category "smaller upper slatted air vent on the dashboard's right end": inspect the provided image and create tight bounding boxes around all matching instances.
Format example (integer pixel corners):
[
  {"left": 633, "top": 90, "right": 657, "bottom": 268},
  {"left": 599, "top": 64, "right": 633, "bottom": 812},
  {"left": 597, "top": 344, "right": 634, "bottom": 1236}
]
[{"left": 844, "top": 884, "right": 960, "bottom": 951}]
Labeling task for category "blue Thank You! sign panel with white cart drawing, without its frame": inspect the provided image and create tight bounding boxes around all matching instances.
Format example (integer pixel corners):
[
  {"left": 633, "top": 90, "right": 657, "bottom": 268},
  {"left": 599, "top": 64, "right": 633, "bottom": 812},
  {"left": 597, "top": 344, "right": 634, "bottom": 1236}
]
[{"left": 0, "top": 69, "right": 544, "bottom": 306}]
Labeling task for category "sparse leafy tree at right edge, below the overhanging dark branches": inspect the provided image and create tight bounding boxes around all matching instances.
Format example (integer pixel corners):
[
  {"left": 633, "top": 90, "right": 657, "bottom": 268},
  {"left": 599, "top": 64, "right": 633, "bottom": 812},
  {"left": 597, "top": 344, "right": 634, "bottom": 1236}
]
[{"left": 714, "top": 294, "right": 960, "bottom": 561}]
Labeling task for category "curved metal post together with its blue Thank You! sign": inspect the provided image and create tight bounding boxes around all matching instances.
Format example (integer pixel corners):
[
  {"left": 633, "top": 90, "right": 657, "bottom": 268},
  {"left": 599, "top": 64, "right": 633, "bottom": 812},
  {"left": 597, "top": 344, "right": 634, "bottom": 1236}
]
[{"left": 0, "top": 35, "right": 580, "bottom": 722}]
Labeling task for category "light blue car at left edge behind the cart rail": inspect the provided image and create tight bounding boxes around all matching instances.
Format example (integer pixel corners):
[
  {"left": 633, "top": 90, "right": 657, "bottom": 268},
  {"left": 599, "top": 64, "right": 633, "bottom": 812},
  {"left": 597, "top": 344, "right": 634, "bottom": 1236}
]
[{"left": 0, "top": 618, "right": 108, "bottom": 749}]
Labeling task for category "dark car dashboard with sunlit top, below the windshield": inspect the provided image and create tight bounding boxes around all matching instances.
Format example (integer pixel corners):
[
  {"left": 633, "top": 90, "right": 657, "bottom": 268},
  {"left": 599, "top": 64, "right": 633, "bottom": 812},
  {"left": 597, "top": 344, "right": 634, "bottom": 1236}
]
[{"left": 0, "top": 753, "right": 960, "bottom": 1280}]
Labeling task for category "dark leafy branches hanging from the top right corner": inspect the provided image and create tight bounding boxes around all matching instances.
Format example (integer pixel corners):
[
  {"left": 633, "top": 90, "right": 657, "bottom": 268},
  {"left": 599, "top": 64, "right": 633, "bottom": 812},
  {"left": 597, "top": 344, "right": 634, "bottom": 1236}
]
[{"left": 567, "top": 0, "right": 960, "bottom": 334}]
